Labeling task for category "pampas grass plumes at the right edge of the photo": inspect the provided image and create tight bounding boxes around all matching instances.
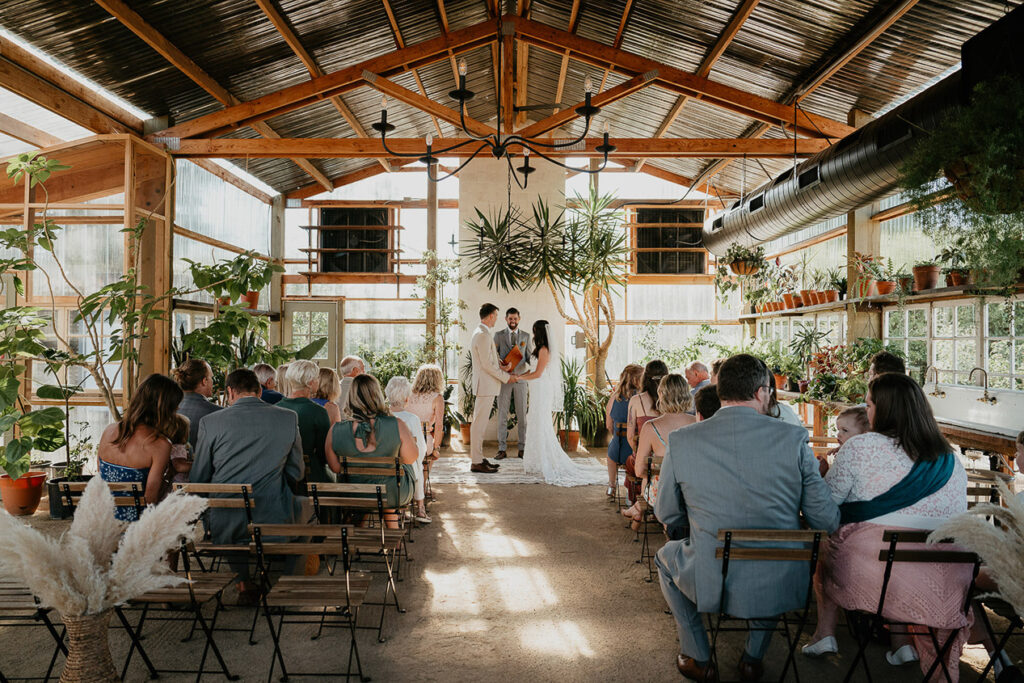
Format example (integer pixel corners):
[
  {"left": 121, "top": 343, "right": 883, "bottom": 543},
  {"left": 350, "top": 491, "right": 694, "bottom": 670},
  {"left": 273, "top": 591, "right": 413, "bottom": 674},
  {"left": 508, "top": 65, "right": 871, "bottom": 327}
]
[{"left": 928, "top": 479, "right": 1024, "bottom": 615}]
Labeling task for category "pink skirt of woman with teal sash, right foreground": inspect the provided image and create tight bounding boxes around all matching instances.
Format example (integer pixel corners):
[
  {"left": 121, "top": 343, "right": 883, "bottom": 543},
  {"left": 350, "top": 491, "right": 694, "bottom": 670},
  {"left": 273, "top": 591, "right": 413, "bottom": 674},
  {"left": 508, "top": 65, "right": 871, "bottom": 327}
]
[{"left": 818, "top": 522, "right": 973, "bottom": 683}]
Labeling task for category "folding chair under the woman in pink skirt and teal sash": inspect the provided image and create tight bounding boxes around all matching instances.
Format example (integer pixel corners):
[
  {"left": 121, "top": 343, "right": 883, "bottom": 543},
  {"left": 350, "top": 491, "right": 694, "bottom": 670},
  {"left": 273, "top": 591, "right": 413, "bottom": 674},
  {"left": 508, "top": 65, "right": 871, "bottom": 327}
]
[{"left": 843, "top": 529, "right": 981, "bottom": 683}]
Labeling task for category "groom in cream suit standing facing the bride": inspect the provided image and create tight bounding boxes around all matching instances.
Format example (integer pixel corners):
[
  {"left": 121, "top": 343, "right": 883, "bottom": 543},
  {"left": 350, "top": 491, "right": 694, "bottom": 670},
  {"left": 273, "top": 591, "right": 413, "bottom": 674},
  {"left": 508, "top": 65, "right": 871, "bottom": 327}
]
[{"left": 469, "top": 303, "right": 516, "bottom": 474}]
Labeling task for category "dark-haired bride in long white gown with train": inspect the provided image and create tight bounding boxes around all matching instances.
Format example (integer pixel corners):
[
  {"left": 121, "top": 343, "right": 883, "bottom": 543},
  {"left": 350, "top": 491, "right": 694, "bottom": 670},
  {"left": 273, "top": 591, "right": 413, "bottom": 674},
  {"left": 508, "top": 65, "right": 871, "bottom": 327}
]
[{"left": 519, "top": 321, "right": 608, "bottom": 486}]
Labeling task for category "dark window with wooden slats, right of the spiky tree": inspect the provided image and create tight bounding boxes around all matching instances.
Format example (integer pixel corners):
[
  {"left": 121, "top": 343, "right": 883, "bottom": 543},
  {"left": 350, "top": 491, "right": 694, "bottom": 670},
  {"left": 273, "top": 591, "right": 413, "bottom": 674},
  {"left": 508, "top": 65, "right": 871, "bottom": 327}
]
[{"left": 630, "top": 208, "right": 708, "bottom": 275}]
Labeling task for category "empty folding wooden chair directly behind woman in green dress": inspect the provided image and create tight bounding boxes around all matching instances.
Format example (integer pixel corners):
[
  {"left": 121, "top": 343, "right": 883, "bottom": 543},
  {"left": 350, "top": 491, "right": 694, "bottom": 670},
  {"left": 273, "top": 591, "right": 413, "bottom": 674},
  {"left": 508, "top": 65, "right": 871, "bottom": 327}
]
[{"left": 307, "top": 483, "right": 406, "bottom": 643}]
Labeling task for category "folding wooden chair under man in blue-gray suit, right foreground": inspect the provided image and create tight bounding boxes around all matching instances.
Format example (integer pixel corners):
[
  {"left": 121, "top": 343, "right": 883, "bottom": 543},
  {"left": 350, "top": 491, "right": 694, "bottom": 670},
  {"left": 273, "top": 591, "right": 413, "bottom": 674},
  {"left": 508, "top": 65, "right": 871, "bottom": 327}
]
[{"left": 707, "top": 528, "right": 828, "bottom": 683}]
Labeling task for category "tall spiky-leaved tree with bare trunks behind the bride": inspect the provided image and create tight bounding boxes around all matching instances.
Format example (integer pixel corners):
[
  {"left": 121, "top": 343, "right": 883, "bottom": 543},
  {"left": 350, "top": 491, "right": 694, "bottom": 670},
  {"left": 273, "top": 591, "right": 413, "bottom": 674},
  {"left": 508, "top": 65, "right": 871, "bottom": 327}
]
[{"left": 462, "top": 185, "right": 627, "bottom": 386}]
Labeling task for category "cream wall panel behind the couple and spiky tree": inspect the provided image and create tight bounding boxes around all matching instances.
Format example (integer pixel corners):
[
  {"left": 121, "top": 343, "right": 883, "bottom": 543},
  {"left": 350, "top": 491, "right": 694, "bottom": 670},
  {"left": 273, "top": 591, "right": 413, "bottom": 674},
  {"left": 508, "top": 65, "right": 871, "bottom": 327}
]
[{"left": 459, "top": 158, "right": 565, "bottom": 441}]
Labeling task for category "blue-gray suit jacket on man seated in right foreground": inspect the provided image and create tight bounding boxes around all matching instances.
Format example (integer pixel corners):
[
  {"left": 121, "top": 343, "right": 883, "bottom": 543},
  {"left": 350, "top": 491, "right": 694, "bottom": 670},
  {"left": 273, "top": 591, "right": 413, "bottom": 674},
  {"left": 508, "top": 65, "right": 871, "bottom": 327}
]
[{"left": 654, "top": 407, "right": 839, "bottom": 618}]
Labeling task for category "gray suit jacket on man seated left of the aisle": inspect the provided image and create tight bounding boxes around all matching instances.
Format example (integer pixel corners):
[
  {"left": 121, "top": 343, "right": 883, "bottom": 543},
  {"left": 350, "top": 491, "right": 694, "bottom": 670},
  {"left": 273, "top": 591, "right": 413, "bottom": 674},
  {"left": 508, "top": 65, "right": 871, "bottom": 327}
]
[{"left": 188, "top": 396, "right": 304, "bottom": 543}]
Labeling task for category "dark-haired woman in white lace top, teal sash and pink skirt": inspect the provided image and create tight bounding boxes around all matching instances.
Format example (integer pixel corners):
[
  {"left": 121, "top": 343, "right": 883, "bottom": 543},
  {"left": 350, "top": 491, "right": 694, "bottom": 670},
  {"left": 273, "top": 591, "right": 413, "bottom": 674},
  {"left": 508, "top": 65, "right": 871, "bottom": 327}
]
[{"left": 804, "top": 373, "right": 972, "bottom": 682}]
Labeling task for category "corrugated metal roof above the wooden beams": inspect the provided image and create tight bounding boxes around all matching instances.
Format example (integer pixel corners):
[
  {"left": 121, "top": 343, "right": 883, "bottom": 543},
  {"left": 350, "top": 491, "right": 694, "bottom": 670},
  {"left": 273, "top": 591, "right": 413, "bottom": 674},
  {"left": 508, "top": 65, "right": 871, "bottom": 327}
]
[{"left": 0, "top": 0, "right": 1022, "bottom": 191}]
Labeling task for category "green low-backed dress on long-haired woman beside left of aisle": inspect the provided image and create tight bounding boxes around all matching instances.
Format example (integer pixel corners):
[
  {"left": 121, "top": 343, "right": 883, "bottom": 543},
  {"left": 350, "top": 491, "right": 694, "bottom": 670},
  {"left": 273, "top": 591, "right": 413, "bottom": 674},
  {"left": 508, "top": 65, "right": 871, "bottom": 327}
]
[{"left": 331, "top": 415, "right": 415, "bottom": 508}]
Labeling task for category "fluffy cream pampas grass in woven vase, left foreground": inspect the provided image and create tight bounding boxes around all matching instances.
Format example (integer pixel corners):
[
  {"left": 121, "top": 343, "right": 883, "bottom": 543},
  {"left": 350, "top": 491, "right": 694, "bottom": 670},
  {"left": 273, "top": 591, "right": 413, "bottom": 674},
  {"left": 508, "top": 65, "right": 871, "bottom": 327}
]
[{"left": 0, "top": 477, "right": 207, "bottom": 616}]
